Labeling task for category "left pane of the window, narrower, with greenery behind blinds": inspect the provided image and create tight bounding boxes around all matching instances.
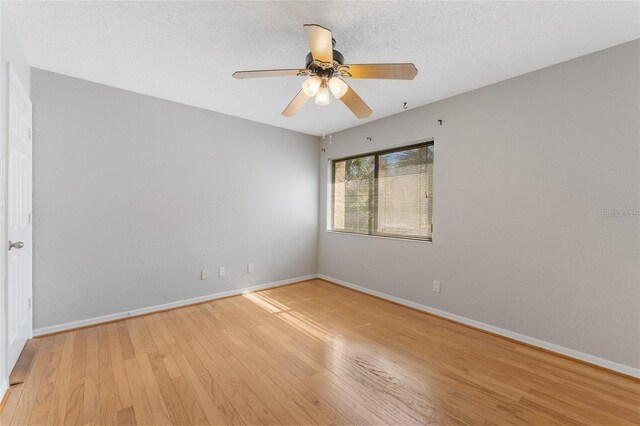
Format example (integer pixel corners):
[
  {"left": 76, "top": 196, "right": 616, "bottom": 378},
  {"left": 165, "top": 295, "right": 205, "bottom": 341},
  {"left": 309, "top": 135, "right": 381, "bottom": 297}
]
[{"left": 333, "top": 155, "right": 375, "bottom": 234}]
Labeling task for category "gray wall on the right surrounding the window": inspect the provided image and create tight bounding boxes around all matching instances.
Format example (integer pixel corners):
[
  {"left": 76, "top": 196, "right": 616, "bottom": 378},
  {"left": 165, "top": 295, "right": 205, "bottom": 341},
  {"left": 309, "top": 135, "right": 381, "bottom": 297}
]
[{"left": 319, "top": 41, "right": 640, "bottom": 368}]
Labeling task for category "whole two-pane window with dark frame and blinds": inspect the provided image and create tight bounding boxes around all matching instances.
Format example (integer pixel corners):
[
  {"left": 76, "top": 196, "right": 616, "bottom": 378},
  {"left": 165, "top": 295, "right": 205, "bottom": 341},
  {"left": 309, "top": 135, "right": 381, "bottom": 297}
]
[{"left": 330, "top": 142, "right": 433, "bottom": 241}]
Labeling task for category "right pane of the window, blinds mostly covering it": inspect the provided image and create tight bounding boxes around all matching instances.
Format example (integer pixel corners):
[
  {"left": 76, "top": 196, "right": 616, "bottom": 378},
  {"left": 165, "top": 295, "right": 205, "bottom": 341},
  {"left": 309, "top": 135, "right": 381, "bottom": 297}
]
[{"left": 376, "top": 145, "right": 433, "bottom": 238}]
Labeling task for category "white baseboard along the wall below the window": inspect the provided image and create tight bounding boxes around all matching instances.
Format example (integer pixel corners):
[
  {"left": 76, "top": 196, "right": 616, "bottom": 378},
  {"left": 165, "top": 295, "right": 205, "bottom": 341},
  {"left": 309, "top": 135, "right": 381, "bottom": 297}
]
[{"left": 318, "top": 274, "right": 640, "bottom": 378}]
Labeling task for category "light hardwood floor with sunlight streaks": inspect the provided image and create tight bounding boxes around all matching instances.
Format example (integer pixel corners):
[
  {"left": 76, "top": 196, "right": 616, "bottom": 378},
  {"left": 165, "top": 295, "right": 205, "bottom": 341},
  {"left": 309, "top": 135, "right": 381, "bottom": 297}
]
[{"left": 0, "top": 280, "right": 640, "bottom": 425}]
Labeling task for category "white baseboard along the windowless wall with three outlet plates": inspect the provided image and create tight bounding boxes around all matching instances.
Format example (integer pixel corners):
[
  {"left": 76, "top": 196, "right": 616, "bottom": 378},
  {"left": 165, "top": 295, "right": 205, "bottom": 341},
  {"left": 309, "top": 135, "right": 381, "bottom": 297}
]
[{"left": 33, "top": 274, "right": 318, "bottom": 337}]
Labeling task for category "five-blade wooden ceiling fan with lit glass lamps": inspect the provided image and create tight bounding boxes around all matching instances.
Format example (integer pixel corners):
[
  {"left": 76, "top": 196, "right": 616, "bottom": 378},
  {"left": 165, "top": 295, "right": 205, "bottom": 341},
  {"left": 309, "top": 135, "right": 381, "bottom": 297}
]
[{"left": 233, "top": 24, "right": 418, "bottom": 118}]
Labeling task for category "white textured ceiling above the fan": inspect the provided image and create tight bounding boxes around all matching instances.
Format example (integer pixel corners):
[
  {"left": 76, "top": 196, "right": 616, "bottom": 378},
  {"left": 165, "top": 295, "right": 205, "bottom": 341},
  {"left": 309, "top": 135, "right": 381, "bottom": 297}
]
[{"left": 3, "top": 1, "right": 640, "bottom": 135}]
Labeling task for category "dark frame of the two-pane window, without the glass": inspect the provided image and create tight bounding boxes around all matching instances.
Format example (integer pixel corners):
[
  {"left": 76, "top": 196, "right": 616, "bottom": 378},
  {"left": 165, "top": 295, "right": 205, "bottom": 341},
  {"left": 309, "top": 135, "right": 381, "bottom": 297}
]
[{"left": 327, "top": 139, "right": 435, "bottom": 243}]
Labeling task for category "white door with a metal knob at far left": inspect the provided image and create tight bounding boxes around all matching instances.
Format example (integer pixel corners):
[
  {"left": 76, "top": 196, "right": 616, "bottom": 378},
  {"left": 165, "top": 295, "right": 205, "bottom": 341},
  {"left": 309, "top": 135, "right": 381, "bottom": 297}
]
[{"left": 5, "top": 68, "right": 32, "bottom": 371}]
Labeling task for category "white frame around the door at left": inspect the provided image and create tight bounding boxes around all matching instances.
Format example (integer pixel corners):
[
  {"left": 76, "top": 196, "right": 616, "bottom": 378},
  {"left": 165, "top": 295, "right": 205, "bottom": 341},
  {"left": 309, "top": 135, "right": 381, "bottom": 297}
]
[{"left": 2, "top": 63, "right": 33, "bottom": 375}]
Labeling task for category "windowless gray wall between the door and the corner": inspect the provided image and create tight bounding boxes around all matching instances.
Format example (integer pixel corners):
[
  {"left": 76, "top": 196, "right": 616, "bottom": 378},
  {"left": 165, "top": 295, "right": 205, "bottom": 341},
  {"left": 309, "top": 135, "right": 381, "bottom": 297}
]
[{"left": 31, "top": 69, "right": 319, "bottom": 329}]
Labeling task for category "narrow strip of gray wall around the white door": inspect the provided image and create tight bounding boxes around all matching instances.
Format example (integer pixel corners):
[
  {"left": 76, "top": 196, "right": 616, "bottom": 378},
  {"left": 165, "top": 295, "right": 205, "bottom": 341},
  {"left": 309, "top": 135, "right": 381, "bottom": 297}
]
[{"left": 0, "top": 3, "right": 30, "bottom": 397}]
